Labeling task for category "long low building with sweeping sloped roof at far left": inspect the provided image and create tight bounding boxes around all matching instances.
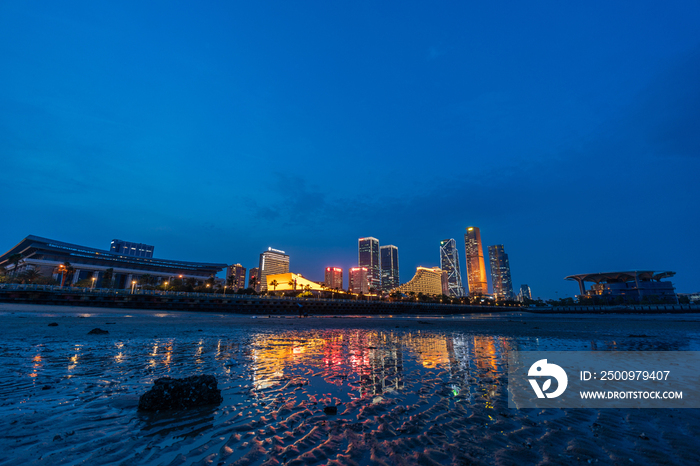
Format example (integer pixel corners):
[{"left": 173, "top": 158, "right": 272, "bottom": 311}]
[{"left": 0, "top": 235, "right": 226, "bottom": 289}]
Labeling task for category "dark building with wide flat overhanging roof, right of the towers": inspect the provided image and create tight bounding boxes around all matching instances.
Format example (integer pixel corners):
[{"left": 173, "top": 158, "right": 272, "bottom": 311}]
[{"left": 565, "top": 270, "right": 678, "bottom": 304}]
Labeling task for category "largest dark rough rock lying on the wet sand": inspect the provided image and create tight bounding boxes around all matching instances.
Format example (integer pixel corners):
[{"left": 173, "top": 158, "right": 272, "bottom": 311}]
[{"left": 139, "top": 375, "right": 223, "bottom": 411}]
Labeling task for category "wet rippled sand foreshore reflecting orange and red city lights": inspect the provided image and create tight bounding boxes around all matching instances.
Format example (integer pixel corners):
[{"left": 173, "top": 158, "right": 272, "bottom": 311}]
[{"left": 0, "top": 304, "right": 700, "bottom": 465}]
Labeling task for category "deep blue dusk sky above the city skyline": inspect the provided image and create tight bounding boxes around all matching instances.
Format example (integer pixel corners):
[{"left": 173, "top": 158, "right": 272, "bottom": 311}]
[{"left": 0, "top": 1, "right": 700, "bottom": 299}]
